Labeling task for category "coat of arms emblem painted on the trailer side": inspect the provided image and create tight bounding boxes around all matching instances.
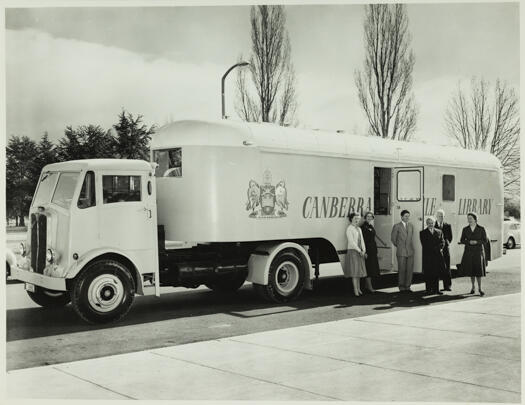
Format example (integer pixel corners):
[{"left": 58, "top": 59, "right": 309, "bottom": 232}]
[{"left": 246, "top": 170, "right": 289, "bottom": 218}]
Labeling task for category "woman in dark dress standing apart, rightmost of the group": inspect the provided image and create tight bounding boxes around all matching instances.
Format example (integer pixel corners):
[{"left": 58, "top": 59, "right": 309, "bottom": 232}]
[{"left": 459, "top": 212, "right": 490, "bottom": 297}]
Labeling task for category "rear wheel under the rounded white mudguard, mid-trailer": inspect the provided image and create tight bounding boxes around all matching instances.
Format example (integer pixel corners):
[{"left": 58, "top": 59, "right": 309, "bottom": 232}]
[{"left": 254, "top": 250, "right": 306, "bottom": 303}]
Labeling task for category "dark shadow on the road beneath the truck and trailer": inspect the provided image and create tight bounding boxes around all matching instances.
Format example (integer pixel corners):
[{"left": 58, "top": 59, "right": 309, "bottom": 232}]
[{"left": 7, "top": 275, "right": 465, "bottom": 342}]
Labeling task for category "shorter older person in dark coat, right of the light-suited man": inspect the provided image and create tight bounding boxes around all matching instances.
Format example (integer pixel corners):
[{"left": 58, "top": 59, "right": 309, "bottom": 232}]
[{"left": 419, "top": 217, "right": 445, "bottom": 295}]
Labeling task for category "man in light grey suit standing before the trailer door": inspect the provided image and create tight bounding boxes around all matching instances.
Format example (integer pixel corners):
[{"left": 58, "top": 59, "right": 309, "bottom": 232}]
[{"left": 390, "top": 210, "right": 414, "bottom": 293}]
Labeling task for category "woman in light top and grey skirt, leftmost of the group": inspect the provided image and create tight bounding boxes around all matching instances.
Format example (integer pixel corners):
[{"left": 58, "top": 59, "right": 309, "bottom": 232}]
[{"left": 344, "top": 212, "right": 366, "bottom": 297}]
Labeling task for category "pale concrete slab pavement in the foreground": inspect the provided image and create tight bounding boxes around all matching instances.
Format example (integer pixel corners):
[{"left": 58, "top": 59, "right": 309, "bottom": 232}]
[{"left": 7, "top": 294, "right": 521, "bottom": 402}]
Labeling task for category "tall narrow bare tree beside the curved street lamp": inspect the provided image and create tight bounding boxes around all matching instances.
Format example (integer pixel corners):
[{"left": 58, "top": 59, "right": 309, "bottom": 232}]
[{"left": 235, "top": 6, "right": 297, "bottom": 125}]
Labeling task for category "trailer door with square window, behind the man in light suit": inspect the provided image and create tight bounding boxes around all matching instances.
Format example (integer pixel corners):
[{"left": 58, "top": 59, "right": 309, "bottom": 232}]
[{"left": 392, "top": 166, "right": 425, "bottom": 273}]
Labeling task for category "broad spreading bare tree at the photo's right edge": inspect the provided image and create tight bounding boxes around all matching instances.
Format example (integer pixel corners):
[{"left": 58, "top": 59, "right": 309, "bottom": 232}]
[{"left": 445, "top": 78, "right": 520, "bottom": 192}]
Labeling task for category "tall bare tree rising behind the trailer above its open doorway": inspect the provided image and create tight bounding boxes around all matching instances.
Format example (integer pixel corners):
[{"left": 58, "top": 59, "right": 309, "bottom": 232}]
[{"left": 355, "top": 4, "right": 417, "bottom": 140}]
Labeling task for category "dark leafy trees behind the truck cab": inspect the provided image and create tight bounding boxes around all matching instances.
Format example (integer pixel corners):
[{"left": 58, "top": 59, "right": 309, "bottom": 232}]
[{"left": 6, "top": 110, "right": 155, "bottom": 226}]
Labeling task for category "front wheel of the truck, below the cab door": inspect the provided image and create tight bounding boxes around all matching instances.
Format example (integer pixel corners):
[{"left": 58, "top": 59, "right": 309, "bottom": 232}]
[{"left": 71, "top": 259, "right": 135, "bottom": 323}]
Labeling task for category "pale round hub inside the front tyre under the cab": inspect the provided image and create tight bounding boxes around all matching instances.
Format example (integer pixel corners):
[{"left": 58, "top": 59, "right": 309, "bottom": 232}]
[{"left": 88, "top": 274, "right": 124, "bottom": 312}]
